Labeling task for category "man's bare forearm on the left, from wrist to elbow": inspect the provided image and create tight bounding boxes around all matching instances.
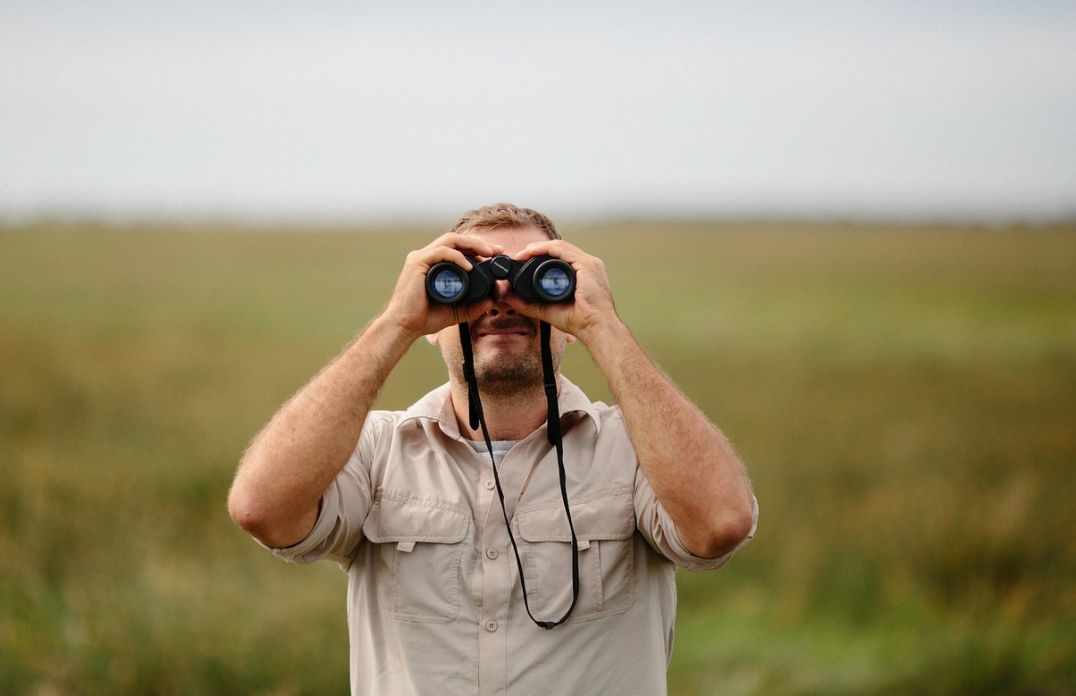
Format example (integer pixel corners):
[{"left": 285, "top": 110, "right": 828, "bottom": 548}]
[{"left": 228, "top": 315, "right": 415, "bottom": 546}]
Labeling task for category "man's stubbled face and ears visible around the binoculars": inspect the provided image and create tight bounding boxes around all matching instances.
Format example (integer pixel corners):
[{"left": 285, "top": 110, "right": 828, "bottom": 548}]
[{"left": 430, "top": 227, "right": 567, "bottom": 396}]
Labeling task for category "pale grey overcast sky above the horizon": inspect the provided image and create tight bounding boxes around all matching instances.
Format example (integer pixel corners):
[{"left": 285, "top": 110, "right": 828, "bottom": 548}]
[{"left": 0, "top": 0, "right": 1076, "bottom": 219}]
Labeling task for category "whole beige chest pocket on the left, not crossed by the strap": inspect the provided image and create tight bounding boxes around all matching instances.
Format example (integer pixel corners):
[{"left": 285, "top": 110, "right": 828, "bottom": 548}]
[{"left": 363, "top": 491, "right": 470, "bottom": 623}]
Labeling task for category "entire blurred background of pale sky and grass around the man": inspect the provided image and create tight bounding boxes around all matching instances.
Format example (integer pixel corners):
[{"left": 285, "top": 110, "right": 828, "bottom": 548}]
[{"left": 0, "top": 0, "right": 1076, "bottom": 696}]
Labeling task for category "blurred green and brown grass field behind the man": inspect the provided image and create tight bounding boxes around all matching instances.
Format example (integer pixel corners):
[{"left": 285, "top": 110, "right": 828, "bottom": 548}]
[{"left": 0, "top": 223, "right": 1076, "bottom": 696}]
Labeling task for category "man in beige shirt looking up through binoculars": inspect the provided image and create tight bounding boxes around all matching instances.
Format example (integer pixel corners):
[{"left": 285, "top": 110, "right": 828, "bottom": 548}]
[{"left": 228, "top": 204, "right": 758, "bottom": 696}]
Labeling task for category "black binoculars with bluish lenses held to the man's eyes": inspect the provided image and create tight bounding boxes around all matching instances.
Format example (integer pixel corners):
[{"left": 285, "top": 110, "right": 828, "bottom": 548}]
[{"left": 426, "top": 254, "right": 576, "bottom": 304}]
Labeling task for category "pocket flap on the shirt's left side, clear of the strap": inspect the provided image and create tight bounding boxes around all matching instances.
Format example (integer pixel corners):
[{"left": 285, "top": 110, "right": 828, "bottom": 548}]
[{"left": 363, "top": 491, "right": 470, "bottom": 543}]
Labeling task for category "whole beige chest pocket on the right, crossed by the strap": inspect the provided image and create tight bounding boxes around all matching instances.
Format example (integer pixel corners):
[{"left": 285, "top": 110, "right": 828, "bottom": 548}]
[{"left": 513, "top": 492, "right": 635, "bottom": 623}]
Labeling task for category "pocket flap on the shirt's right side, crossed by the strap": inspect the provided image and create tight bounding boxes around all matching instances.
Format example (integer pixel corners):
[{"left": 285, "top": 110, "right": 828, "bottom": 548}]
[{"left": 515, "top": 492, "right": 635, "bottom": 542}]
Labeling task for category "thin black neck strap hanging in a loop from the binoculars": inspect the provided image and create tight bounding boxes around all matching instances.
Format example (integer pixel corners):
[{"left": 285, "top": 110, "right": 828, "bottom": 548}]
[{"left": 459, "top": 322, "right": 579, "bottom": 628}]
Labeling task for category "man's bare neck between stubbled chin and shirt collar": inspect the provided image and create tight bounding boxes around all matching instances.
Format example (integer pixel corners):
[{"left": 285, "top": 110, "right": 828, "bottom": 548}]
[{"left": 452, "top": 380, "right": 548, "bottom": 440}]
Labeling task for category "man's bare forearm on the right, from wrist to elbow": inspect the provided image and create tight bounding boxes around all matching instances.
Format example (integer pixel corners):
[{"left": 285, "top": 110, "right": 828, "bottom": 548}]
[{"left": 584, "top": 319, "right": 753, "bottom": 557}]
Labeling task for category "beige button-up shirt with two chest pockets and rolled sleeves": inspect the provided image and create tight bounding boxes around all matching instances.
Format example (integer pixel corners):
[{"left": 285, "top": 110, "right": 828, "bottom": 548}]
[{"left": 273, "top": 378, "right": 758, "bottom": 696}]
